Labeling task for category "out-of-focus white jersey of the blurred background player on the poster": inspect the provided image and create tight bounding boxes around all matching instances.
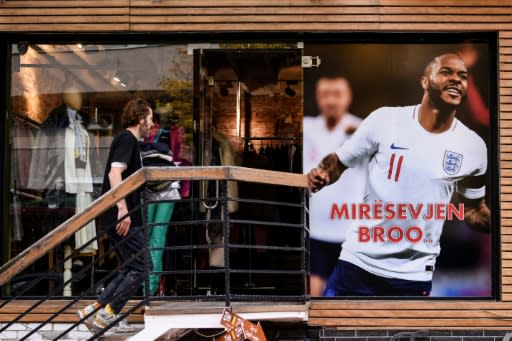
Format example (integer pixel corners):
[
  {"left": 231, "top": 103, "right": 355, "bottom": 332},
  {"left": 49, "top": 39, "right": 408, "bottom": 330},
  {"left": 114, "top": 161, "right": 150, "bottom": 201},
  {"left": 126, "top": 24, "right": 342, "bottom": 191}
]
[{"left": 303, "top": 113, "right": 368, "bottom": 243}]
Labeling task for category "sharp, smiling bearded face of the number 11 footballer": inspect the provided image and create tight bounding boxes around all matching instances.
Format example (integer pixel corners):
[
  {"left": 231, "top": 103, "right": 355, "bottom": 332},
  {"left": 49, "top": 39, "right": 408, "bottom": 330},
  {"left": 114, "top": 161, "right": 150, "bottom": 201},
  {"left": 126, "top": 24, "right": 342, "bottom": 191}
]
[{"left": 425, "top": 54, "right": 468, "bottom": 107}]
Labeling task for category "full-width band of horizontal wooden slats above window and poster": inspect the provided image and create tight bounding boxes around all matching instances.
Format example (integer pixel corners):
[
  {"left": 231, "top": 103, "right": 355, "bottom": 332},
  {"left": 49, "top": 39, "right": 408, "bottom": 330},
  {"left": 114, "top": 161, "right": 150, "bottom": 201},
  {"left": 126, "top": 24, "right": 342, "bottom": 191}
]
[{"left": 0, "top": 0, "right": 512, "bottom": 32}]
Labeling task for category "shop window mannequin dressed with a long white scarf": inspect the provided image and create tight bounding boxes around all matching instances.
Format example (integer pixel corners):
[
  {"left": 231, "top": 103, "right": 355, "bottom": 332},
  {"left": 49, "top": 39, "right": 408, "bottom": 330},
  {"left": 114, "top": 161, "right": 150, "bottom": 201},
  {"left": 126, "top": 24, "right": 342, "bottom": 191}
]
[{"left": 28, "top": 86, "right": 98, "bottom": 254}]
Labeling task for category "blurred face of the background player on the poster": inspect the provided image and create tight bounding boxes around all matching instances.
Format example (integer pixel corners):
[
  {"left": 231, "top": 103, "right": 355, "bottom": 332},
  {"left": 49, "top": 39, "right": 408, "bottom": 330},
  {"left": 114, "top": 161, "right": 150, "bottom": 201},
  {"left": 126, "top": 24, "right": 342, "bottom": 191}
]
[{"left": 316, "top": 78, "right": 352, "bottom": 121}]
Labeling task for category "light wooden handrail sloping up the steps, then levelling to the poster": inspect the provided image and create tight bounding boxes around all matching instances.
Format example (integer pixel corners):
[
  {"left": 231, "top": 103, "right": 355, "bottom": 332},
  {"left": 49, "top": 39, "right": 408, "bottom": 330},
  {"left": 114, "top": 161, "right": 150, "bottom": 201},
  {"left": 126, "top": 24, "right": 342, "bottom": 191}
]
[{"left": 0, "top": 166, "right": 307, "bottom": 286}]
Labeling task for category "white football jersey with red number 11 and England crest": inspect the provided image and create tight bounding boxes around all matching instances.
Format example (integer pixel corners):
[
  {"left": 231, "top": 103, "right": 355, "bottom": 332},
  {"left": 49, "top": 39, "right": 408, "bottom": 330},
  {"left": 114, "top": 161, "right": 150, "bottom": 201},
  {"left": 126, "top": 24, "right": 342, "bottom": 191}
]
[{"left": 336, "top": 105, "right": 487, "bottom": 281}]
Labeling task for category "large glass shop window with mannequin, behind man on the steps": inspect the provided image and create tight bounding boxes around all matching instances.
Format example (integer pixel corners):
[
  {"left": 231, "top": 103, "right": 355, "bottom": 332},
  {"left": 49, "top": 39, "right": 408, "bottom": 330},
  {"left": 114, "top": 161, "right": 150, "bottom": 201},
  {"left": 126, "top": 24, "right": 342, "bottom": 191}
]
[{"left": 8, "top": 44, "right": 193, "bottom": 294}]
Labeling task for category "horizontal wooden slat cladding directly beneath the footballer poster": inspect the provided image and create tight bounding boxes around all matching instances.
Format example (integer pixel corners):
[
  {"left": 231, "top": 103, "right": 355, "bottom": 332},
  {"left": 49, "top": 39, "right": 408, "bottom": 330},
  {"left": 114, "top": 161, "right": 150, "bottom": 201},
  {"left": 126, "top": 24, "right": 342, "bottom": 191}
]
[{"left": 309, "top": 301, "right": 512, "bottom": 329}]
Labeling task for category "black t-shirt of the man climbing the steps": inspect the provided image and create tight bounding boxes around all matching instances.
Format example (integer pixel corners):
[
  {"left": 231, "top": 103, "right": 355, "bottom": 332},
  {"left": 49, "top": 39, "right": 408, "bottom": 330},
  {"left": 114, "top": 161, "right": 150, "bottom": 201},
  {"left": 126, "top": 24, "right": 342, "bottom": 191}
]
[{"left": 101, "top": 130, "right": 142, "bottom": 228}]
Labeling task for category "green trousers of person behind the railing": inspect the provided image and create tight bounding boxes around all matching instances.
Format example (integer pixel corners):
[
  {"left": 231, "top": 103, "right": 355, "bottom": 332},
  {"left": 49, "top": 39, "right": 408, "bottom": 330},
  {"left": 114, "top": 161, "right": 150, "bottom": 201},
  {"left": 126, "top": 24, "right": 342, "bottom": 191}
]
[{"left": 148, "top": 202, "right": 174, "bottom": 295}]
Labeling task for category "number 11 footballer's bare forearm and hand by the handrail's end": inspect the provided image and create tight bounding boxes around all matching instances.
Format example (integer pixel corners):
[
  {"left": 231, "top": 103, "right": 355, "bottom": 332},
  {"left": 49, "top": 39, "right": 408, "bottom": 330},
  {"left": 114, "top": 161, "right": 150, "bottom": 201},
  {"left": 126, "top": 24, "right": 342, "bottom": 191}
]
[{"left": 308, "top": 153, "right": 347, "bottom": 193}]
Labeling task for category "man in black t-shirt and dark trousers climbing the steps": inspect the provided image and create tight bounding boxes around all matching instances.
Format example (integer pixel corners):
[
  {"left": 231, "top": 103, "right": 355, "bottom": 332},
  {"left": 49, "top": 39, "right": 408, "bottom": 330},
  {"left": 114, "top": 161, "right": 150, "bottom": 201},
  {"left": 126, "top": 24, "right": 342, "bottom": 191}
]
[{"left": 77, "top": 98, "right": 153, "bottom": 332}]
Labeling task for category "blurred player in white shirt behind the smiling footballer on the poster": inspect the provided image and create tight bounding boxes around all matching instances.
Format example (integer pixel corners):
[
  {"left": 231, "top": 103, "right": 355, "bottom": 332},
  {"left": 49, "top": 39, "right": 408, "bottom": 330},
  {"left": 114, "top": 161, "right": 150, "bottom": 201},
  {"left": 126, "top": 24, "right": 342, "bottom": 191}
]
[{"left": 304, "top": 76, "right": 366, "bottom": 296}]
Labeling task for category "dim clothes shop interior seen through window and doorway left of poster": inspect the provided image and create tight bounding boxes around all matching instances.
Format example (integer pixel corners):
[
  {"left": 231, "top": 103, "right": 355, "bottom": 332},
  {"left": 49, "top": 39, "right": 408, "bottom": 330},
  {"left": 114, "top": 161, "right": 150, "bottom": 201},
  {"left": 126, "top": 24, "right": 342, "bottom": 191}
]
[{"left": 3, "top": 44, "right": 303, "bottom": 296}]
